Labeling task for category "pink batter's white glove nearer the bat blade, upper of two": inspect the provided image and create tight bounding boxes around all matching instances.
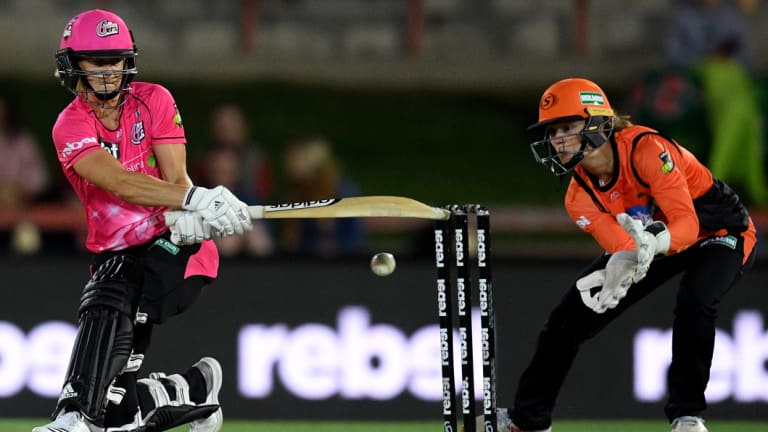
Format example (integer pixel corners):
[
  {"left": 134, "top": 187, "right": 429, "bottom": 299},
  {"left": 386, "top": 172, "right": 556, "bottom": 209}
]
[{"left": 182, "top": 186, "right": 253, "bottom": 235}]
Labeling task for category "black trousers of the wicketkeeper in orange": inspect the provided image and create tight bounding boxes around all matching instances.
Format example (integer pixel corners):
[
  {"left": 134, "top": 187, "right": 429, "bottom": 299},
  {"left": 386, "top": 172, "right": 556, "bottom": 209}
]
[{"left": 512, "top": 236, "right": 754, "bottom": 430}]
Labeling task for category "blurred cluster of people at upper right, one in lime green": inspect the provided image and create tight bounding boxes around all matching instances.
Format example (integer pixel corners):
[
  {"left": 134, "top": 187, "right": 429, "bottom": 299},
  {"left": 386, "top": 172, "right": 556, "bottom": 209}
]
[{"left": 624, "top": 0, "right": 768, "bottom": 209}]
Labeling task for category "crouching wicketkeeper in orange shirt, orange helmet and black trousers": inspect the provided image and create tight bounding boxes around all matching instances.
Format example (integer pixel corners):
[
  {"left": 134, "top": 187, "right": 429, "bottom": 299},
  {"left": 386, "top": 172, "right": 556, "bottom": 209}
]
[{"left": 498, "top": 79, "right": 755, "bottom": 432}]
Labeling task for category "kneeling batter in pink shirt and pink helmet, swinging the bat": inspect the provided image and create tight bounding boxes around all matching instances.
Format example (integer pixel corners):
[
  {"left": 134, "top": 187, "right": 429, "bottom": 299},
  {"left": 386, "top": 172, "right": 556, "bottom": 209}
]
[{"left": 34, "top": 10, "right": 251, "bottom": 432}]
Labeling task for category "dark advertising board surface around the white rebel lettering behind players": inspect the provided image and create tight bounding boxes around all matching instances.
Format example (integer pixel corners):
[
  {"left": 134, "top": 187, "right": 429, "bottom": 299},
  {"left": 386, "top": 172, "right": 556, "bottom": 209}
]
[{"left": 0, "top": 257, "right": 768, "bottom": 420}]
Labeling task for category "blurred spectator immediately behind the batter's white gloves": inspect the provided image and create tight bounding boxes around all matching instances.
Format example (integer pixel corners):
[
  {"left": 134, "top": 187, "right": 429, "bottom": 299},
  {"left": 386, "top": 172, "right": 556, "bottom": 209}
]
[{"left": 198, "top": 146, "right": 274, "bottom": 257}]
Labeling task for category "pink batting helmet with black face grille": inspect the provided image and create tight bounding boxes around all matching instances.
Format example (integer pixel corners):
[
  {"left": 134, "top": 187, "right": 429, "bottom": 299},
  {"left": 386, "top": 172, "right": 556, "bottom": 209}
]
[{"left": 56, "top": 9, "right": 137, "bottom": 99}]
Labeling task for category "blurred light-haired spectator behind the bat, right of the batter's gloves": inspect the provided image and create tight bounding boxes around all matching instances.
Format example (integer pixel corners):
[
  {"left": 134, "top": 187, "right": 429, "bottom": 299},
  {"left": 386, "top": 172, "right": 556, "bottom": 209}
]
[{"left": 280, "top": 136, "right": 366, "bottom": 256}]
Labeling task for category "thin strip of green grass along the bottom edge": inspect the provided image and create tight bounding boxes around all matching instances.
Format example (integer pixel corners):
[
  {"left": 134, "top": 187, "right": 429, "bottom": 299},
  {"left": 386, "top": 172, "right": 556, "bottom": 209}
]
[{"left": 9, "top": 419, "right": 768, "bottom": 432}]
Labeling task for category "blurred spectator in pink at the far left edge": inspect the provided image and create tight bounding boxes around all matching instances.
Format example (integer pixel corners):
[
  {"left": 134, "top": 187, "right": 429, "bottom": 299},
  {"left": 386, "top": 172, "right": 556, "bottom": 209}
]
[{"left": 0, "top": 90, "right": 49, "bottom": 254}]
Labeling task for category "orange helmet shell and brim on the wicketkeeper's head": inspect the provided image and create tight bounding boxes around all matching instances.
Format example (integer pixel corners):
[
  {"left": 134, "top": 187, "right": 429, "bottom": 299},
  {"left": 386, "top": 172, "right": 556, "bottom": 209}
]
[{"left": 528, "top": 78, "right": 613, "bottom": 130}]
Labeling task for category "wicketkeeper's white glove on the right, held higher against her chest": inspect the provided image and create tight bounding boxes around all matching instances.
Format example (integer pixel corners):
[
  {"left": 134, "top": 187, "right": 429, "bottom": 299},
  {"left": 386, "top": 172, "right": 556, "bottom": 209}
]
[{"left": 616, "top": 213, "right": 671, "bottom": 282}]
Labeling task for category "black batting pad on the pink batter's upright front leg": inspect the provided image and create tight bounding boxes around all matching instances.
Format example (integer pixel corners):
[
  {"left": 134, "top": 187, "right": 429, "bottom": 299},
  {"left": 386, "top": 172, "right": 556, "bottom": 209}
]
[{"left": 54, "top": 255, "right": 142, "bottom": 424}]
